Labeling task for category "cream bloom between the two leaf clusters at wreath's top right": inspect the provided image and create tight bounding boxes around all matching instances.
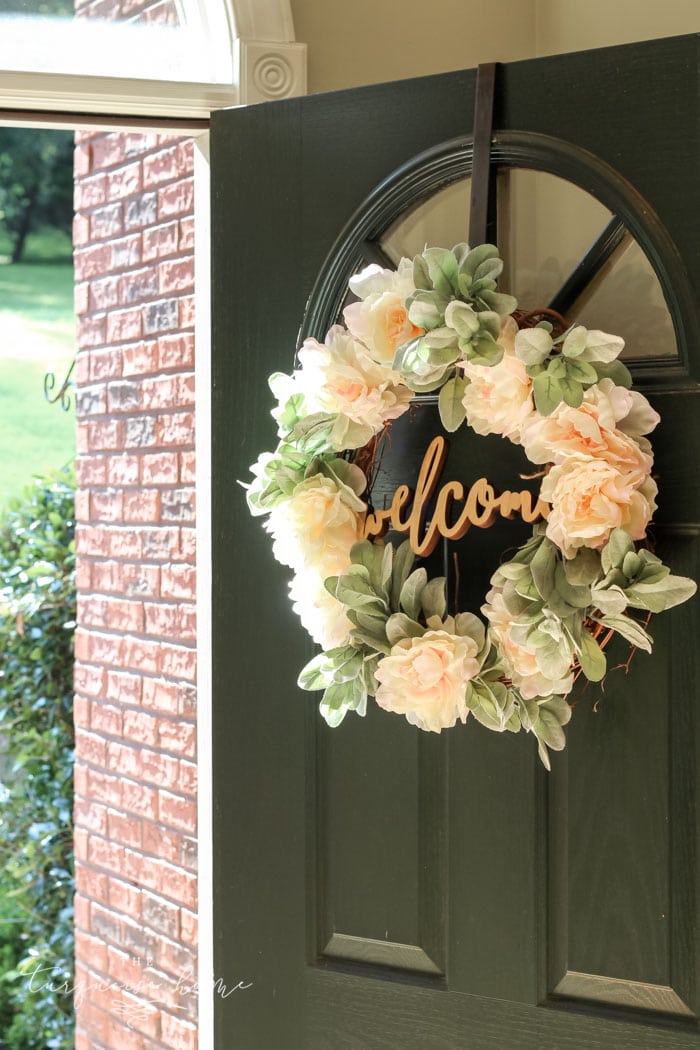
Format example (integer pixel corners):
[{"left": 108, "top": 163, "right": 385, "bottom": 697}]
[{"left": 462, "top": 317, "right": 534, "bottom": 444}]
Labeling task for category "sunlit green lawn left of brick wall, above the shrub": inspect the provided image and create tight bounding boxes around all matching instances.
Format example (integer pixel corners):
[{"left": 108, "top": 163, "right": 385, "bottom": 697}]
[{"left": 0, "top": 263, "right": 76, "bottom": 508}]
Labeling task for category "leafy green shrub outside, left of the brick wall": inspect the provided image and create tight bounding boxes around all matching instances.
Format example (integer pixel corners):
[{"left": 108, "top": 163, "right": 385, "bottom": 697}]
[{"left": 0, "top": 470, "right": 76, "bottom": 1050}]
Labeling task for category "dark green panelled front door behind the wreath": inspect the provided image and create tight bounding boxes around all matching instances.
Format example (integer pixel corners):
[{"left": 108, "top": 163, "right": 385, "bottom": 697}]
[{"left": 212, "top": 37, "right": 700, "bottom": 1050}]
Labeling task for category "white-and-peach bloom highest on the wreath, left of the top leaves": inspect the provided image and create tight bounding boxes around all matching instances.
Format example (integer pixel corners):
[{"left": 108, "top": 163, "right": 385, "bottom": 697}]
[{"left": 343, "top": 259, "right": 424, "bottom": 364}]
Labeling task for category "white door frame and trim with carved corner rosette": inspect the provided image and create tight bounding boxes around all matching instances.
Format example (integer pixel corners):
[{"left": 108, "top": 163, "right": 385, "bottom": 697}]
[{"left": 0, "top": 0, "right": 306, "bottom": 1047}]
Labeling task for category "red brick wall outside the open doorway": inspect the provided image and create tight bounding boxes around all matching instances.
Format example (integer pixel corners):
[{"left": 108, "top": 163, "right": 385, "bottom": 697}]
[{"left": 75, "top": 129, "right": 197, "bottom": 1050}]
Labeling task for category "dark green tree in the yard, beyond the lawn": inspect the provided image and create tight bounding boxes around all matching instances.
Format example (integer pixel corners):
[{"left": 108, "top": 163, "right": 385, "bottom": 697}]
[{"left": 0, "top": 128, "right": 72, "bottom": 263}]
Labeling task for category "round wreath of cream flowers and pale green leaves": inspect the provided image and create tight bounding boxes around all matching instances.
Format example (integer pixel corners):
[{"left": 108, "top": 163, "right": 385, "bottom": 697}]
[{"left": 246, "top": 245, "right": 696, "bottom": 769}]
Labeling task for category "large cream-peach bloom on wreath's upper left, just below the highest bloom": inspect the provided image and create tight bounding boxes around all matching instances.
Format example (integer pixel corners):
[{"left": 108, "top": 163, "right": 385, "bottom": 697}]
[{"left": 295, "top": 324, "right": 413, "bottom": 452}]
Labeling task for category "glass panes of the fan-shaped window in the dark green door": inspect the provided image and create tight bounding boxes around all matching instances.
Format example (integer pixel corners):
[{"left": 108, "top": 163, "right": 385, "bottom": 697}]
[{"left": 381, "top": 168, "right": 678, "bottom": 359}]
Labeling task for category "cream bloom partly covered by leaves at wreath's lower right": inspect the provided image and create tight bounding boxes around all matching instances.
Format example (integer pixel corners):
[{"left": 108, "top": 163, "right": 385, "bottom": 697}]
[{"left": 482, "top": 587, "right": 574, "bottom": 700}]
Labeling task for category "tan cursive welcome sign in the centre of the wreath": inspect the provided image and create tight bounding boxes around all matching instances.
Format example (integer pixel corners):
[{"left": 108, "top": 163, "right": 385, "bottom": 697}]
[{"left": 364, "top": 437, "right": 550, "bottom": 558}]
